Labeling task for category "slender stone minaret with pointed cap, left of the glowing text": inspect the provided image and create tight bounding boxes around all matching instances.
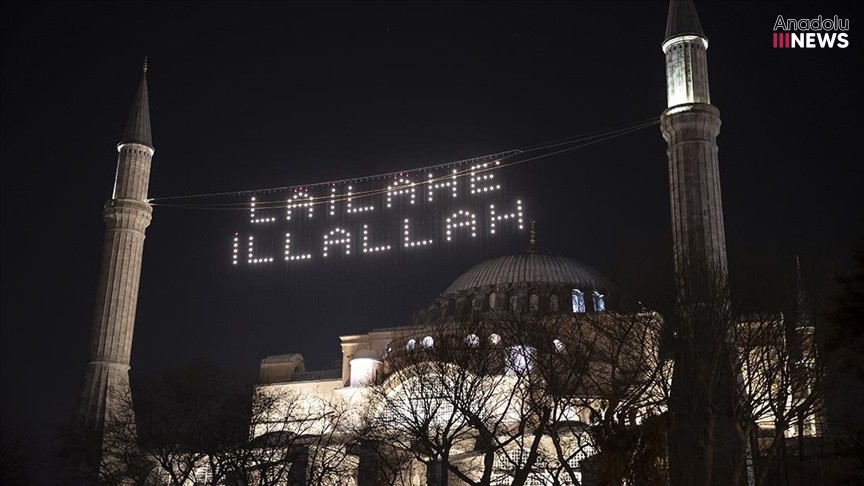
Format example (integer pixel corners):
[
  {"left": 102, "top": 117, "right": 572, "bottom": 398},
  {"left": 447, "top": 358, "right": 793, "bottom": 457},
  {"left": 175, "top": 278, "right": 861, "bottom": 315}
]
[{"left": 77, "top": 59, "right": 154, "bottom": 435}]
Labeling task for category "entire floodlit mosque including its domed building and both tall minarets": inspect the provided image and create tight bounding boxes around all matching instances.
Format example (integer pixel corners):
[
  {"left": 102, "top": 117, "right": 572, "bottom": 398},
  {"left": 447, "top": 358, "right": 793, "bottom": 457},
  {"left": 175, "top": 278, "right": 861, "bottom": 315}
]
[{"left": 78, "top": 0, "right": 818, "bottom": 485}]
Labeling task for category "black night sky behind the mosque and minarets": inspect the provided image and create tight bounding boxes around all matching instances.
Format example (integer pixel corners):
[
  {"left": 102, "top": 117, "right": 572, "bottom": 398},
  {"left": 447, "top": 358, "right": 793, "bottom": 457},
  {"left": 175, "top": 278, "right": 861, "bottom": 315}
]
[{"left": 0, "top": 1, "right": 864, "bottom": 478}]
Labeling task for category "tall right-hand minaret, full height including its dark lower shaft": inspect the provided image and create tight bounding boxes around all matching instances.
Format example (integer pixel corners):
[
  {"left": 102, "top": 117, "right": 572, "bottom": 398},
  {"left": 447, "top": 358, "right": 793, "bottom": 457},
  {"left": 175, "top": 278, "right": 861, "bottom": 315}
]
[{"left": 660, "top": 0, "right": 742, "bottom": 486}]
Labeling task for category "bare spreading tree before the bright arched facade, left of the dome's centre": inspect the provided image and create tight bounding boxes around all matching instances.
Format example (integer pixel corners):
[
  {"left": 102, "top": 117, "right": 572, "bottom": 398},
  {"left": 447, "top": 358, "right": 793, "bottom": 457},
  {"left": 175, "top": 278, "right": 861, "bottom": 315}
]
[{"left": 369, "top": 322, "right": 520, "bottom": 484}]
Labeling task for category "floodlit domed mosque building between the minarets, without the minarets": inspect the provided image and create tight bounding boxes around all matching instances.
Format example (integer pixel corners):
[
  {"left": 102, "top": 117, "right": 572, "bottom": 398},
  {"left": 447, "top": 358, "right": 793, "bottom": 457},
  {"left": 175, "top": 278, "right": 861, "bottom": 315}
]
[{"left": 255, "top": 250, "right": 668, "bottom": 485}]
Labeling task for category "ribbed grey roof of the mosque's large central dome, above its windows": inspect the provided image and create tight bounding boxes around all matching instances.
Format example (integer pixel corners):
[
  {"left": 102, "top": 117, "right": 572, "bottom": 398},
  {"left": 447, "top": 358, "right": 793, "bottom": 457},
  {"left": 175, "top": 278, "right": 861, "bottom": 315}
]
[{"left": 444, "top": 253, "right": 609, "bottom": 295}]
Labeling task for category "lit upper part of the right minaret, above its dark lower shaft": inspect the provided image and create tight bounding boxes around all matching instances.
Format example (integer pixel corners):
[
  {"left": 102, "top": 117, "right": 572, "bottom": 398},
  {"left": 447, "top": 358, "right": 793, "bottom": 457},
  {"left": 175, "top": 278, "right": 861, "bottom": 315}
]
[{"left": 660, "top": 0, "right": 727, "bottom": 302}]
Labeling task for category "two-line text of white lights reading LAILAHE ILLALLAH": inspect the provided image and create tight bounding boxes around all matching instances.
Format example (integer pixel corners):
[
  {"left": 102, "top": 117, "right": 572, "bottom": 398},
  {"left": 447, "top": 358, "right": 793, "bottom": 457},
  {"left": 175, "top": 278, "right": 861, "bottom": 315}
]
[{"left": 231, "top": 160, "right": 525, "bottom": 266}]
